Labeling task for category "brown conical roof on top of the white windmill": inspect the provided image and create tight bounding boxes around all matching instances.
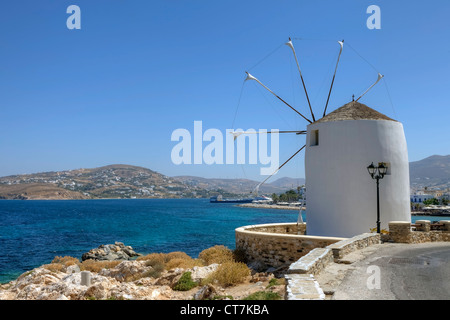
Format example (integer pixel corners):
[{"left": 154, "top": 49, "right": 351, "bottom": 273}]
[{"left": 314, "top": 101, "right": 396, "bottom": 123}]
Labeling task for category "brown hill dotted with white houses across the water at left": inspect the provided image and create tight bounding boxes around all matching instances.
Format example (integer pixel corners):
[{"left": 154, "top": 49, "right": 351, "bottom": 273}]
[{"left": 0, "top": 164, "right": 208, "bottom": 199}]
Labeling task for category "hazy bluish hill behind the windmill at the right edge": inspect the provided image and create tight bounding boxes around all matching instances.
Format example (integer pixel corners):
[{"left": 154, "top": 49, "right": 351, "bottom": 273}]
[{"left": 409, "top": 155, "right": 450, "bottom": 187}]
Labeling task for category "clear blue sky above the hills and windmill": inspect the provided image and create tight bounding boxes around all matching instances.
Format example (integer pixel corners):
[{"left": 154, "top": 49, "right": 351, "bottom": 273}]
[{"left": 0, "top": 0, "right": 450, "bottom": 180}]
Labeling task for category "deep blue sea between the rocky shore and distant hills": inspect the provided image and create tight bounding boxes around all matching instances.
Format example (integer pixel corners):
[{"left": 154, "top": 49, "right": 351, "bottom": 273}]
[{"left": 0, "top": 199, "right": 298, "bottom": 283}]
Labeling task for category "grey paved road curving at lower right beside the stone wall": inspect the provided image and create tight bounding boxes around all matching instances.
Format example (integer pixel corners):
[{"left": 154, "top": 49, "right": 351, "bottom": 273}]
[{"left": 316, "top": 242, "right": 450, "bottom": 300}]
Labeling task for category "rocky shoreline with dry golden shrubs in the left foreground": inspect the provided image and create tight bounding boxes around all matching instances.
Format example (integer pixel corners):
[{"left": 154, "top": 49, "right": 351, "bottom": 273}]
[{"left": 0, "top": 242, "right": 285, "bottom": 300}]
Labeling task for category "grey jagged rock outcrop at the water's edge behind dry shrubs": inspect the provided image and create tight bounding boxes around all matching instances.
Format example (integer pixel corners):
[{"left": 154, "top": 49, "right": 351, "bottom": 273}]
[{"left": 81, "top": 242, "right": 140, "bottom": 261}]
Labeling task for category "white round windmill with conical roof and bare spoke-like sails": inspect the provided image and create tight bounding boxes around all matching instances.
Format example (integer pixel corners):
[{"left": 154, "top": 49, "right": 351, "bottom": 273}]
[{"left": 232, "top": 38, "right": 411, "bottom": 237}]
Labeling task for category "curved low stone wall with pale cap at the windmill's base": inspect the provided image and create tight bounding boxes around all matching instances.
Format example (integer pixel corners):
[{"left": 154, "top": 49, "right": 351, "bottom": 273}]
[{"left": 235, "top": 223, "right": 344, "bottom": 268}]
